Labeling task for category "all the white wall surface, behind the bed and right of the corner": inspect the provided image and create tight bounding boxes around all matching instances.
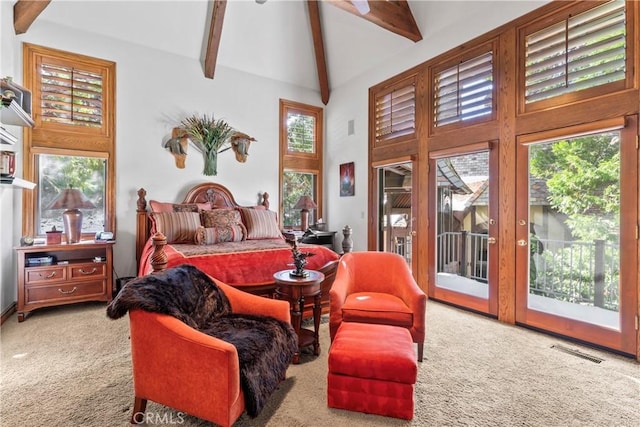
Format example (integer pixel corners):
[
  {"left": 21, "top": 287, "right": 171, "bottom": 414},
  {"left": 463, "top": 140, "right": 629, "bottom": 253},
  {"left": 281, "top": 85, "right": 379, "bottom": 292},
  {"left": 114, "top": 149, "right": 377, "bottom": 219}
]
[{"left": 0, "top": 1, "right": 544, "bottom": 311}]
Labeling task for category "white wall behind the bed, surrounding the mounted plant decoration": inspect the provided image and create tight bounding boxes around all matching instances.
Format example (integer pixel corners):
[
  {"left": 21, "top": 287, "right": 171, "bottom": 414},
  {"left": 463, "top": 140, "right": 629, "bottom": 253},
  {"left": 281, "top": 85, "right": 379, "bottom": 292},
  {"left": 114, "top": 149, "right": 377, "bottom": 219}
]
[{"left": 0, "top": 5, "right": 322, "bottom": 311}]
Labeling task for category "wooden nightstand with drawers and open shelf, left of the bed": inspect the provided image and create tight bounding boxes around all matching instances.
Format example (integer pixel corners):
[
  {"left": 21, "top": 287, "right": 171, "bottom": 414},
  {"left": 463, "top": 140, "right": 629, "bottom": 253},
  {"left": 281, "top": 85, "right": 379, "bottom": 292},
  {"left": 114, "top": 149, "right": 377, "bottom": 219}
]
[{"left": 16, "top": 241, "right": 114, "bottom": 322}]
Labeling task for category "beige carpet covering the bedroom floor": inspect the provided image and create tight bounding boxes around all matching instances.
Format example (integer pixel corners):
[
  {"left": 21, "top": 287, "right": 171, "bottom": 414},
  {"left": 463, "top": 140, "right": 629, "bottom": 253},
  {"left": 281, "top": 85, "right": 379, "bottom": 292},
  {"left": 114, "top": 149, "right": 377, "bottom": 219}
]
[{"left": 0, "top": 301, "right": 640, "bottom": 427}]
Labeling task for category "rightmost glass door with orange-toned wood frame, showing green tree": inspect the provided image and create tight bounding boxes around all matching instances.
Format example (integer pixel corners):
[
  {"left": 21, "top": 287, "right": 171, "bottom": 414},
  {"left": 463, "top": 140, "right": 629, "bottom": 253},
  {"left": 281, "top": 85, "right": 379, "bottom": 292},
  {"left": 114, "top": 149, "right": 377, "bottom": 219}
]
[{"left": 516, "top": 118, "right": 638, "bottom": 354}]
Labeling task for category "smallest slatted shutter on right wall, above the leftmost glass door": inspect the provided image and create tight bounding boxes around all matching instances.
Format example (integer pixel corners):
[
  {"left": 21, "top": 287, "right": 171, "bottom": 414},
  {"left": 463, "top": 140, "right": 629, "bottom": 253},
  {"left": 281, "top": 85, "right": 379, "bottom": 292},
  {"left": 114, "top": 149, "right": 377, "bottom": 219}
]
[{"left": 375, "top": 82, "right": 416, "bottom": 142}]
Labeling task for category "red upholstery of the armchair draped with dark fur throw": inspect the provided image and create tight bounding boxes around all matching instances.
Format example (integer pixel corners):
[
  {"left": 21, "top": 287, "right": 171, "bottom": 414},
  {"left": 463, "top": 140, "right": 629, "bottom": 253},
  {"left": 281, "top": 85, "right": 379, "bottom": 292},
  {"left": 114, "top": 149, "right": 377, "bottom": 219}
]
[{"left": 129, "top": 281, "right": 291, "bottom": 426}]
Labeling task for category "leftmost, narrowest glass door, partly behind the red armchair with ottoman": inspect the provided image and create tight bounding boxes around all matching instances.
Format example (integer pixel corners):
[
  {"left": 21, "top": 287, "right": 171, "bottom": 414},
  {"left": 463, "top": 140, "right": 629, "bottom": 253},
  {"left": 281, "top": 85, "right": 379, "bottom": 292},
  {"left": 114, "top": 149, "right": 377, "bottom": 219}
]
[{"left": 377, "top": 161, "right": 416, "bottom": 270}]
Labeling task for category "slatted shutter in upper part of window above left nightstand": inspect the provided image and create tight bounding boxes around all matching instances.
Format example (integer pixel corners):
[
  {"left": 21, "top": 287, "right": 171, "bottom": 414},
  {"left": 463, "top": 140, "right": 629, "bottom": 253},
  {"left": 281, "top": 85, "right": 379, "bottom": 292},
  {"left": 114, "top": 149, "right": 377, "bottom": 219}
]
[{"left": 40, "top": 63, "right": 103, "bottom": 128}]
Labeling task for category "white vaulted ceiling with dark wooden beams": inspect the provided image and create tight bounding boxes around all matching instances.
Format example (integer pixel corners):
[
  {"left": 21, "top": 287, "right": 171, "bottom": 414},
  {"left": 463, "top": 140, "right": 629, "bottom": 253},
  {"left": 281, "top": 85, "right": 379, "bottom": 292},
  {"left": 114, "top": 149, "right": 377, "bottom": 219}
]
[{"left": 14, "top": 0, "right": 424, "bottom": 104}]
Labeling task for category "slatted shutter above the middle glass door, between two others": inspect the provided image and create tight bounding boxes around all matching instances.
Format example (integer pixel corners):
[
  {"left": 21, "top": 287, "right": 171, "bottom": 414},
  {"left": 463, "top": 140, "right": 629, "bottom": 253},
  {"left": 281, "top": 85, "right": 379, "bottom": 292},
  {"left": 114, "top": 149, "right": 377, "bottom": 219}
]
[{"left": 433, "top": 52, "right": 493, "bottom": 126}]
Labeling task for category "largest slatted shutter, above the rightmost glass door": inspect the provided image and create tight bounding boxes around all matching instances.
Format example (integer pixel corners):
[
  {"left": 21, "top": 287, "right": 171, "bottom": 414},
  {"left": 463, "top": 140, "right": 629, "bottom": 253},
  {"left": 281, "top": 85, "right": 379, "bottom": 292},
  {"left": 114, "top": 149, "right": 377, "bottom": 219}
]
[{"left": 525, "top": 0, "right": 626, "bottom": 103}]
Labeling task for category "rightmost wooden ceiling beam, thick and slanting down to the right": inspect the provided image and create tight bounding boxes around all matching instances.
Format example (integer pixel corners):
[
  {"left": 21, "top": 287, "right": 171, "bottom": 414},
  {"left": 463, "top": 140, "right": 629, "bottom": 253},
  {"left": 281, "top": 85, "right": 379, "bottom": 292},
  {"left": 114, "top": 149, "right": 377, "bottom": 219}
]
[{"left": 325, "top": 0, "right": 422, "bottom": 42}]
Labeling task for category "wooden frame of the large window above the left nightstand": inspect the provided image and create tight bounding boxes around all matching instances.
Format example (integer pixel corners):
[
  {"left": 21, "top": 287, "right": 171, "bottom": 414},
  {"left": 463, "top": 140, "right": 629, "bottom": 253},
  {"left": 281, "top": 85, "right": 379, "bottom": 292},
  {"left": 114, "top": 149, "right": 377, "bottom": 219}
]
[{"left": 22, "top": 43, "right": 116, "bottom": 239}]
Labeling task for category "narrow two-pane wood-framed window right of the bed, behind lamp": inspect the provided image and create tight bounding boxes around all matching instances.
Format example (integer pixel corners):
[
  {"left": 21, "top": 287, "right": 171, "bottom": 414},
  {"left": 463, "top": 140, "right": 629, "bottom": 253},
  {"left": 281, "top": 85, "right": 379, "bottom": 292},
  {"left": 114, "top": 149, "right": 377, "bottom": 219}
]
[{"left": 280, "top": 100, "right": 323, "bottom": 229}]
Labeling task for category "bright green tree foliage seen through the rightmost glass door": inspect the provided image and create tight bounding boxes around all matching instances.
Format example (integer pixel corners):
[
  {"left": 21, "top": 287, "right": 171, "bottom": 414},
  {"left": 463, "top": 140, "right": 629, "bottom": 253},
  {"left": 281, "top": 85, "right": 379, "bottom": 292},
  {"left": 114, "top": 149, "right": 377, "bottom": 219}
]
[{"left": 529, "top": 133, "right": 620, "bottom": 241}]
